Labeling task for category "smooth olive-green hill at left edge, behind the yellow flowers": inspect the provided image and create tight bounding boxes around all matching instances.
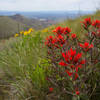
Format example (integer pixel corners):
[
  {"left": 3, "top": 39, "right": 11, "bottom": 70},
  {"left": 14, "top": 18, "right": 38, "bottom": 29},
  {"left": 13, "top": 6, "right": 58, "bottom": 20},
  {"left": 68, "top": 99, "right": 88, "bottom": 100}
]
[{"left": 0, "top": 16, "right": 27, "bottom": 38}]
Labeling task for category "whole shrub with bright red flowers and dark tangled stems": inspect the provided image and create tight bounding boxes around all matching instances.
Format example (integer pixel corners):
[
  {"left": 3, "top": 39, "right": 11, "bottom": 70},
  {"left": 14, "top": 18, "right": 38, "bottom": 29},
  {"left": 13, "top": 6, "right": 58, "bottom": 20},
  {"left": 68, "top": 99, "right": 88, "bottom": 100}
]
[{"left": 45, "top": 18, "right": 100, "bottom": 100}]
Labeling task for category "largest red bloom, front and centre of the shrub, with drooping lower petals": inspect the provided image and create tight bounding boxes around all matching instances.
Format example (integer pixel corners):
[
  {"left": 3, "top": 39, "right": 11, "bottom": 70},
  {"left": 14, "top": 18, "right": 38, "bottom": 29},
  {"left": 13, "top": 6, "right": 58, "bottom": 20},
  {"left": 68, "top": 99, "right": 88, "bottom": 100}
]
[{"left": 59, "top": 48, "right": 85, "bottom": 80}]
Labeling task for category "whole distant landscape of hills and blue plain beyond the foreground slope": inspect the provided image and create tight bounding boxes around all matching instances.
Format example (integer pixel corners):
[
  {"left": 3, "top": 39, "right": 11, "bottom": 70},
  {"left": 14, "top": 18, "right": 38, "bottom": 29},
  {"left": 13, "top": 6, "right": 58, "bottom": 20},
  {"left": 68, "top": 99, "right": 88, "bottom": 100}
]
[{"left": 0, "top": 11, "right": 93, "bottom": 38}]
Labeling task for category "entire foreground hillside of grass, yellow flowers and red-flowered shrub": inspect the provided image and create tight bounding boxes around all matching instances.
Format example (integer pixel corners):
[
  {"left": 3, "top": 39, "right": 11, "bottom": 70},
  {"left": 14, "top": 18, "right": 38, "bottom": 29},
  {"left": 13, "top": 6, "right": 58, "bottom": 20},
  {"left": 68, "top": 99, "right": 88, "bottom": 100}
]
[{"left": 0, "top": 11, "right": 100, "bottom": 100}]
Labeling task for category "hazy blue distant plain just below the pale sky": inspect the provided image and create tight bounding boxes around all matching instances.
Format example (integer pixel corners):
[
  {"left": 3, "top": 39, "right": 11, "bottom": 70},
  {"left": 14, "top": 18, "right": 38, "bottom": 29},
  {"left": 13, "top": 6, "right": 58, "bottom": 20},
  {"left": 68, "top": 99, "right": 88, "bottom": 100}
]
[{"left": 0, "top": 10, "right": 93, "bottom": 21}]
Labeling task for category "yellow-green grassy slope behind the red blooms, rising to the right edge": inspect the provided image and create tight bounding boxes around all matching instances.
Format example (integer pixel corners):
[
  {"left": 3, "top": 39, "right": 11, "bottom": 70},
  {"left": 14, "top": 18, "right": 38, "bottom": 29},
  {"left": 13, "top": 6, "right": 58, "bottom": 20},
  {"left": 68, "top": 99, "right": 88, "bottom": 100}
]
[{"left": 56, "top": 11, "right": 100, "bottom": 36}]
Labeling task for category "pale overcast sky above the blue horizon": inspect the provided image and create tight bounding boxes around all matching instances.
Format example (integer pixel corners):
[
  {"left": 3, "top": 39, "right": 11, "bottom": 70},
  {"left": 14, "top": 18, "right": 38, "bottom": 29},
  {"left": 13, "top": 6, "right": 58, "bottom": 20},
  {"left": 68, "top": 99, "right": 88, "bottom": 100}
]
[{"left": 0, "top": 0, "right": 100, "bottom": 11}]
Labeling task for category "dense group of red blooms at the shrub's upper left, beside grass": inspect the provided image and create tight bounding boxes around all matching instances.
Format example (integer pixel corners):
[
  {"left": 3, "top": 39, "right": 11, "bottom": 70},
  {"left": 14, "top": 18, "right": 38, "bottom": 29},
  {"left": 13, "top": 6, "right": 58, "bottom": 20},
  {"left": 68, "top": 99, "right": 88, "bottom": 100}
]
[{"left": 45, "top": 26, "right": 72, "bottom": 48}]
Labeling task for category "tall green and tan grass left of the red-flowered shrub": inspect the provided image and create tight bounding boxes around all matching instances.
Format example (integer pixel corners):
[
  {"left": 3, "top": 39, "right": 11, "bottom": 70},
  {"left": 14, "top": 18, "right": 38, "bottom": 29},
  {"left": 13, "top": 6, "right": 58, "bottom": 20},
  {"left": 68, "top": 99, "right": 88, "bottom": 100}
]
[{"left": 0, "top": 32, "right": 46, "bottom": 100}]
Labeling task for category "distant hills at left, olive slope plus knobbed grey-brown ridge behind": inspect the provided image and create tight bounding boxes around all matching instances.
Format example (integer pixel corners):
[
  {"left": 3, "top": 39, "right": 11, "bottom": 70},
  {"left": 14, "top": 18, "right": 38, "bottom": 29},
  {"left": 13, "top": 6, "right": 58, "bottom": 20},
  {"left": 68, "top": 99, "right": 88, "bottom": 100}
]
[{"left": 0, "top": 14, "right": 53, "bottom": 38}]
